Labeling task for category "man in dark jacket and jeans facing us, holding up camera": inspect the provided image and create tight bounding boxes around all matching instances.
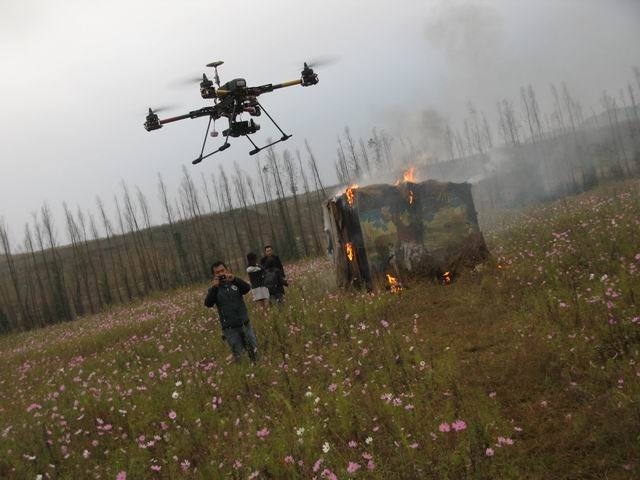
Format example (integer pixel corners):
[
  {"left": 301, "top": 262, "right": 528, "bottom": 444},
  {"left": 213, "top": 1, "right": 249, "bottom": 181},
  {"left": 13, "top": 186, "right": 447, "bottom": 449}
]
[{"left": 204, "top": 261, "right": 258, "bottom": 363}]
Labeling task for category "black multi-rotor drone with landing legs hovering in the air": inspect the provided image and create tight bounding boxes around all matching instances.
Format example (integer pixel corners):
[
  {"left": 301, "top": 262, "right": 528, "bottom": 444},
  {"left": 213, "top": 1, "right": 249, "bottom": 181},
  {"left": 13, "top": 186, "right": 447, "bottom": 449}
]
[{"left": 144, "top": 61, "right": 318, "bottom": 165}]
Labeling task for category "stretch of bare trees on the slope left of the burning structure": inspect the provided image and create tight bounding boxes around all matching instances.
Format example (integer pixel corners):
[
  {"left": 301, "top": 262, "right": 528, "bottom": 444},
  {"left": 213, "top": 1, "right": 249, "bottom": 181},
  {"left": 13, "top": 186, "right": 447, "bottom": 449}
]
[{"left": 0, "top": 141, "right": 338, "bottom": 332}]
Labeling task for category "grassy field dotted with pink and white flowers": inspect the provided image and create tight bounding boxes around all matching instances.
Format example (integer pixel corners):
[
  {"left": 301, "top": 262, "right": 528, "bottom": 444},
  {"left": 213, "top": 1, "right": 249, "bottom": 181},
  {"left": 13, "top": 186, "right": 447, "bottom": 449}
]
[{"left": 0, "top": 181, "right": 640, "bottom": 480}]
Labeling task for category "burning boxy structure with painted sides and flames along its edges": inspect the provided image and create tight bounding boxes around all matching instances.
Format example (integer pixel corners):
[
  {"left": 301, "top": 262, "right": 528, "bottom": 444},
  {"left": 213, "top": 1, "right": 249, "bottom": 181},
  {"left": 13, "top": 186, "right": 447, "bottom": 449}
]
[{"left": 325, "top": 170, "right": 488, "bottom": 292}]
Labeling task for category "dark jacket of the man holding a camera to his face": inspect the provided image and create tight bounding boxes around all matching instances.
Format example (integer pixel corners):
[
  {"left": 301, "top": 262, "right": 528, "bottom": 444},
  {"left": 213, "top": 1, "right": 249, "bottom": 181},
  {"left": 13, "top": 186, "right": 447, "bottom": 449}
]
[{"left": 204, "top": 277, "right": 251, "bottom": 330}]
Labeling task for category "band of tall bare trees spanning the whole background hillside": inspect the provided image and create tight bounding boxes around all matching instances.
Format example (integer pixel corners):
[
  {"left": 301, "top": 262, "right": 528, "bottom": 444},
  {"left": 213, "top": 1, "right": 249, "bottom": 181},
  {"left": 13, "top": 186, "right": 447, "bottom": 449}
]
[{"left": 0, "top": 68, "right": 640, "bottom": 333}]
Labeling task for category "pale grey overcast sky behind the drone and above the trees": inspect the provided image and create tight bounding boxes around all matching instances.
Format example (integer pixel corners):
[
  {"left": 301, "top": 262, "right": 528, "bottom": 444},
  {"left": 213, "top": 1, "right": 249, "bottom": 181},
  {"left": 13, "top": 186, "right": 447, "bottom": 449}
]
[{"left": 0, "top": 0, "right": 640, "bottom": 242}]
